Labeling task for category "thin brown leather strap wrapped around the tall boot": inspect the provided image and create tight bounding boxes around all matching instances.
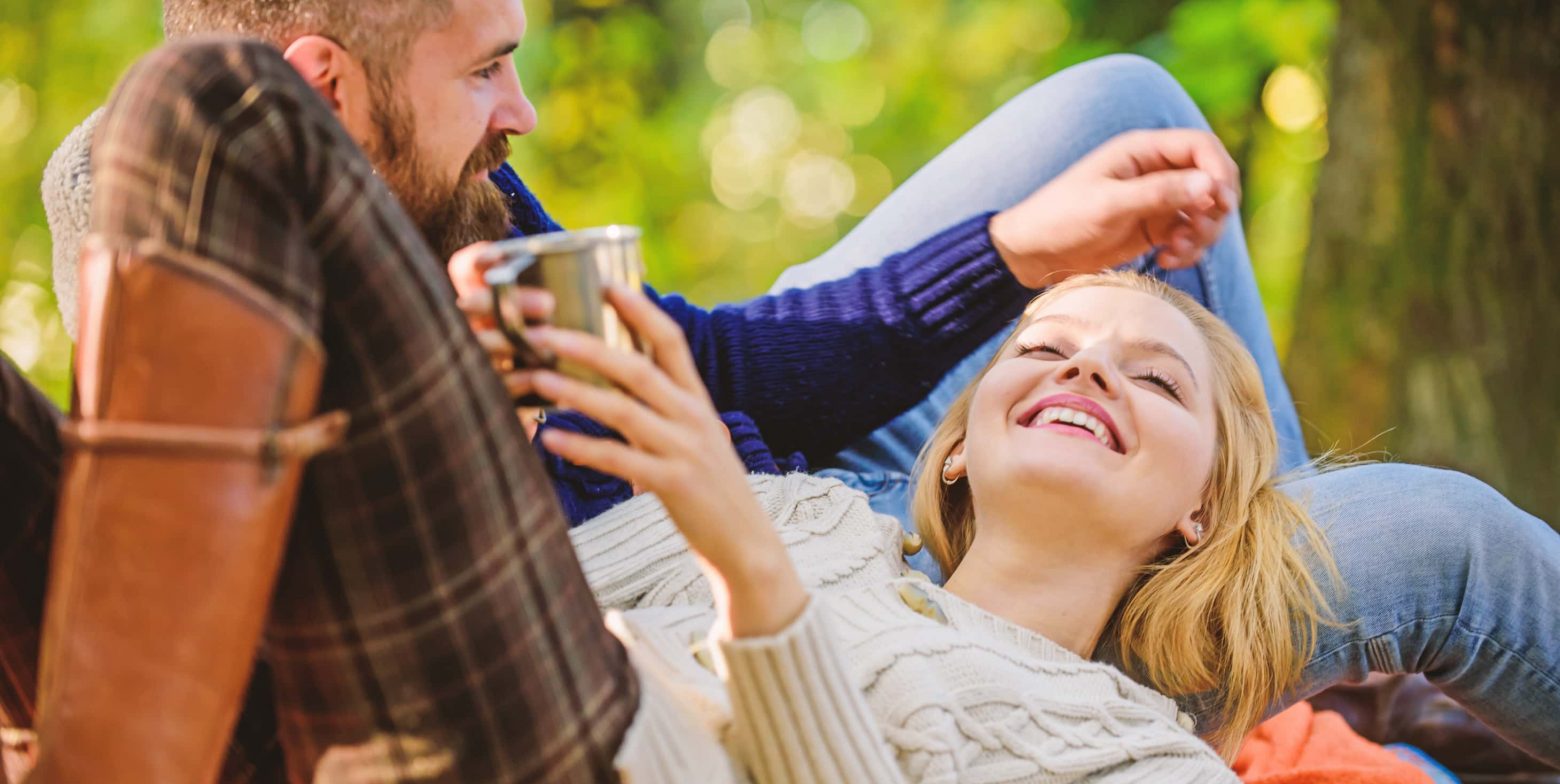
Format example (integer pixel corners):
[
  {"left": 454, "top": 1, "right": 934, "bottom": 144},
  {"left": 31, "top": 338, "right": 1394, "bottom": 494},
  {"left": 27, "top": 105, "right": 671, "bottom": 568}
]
[{"left": 61, "top": 411, "right": 349, "bottom": 461}]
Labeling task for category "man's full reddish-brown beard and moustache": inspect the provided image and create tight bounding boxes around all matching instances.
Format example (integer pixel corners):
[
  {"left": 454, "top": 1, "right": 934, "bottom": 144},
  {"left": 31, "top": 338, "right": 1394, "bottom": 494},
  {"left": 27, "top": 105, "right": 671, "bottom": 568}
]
[{"left": 365, "top": 79, "right": 510, "bottom": 259}]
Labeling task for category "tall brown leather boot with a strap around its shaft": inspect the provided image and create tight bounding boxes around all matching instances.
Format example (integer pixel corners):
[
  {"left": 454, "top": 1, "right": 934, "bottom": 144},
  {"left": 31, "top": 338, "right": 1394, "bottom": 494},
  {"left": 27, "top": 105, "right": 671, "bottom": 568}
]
[{"left": 30, "top": 242, "right": 346, "bottom": 784}]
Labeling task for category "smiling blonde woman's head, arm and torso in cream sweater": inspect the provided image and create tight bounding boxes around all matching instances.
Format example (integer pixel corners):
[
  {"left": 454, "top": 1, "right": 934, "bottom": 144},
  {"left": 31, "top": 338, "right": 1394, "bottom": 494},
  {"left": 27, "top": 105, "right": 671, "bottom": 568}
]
[{"left": 537, "top": 274, "right": 1328, "bottom": 781}]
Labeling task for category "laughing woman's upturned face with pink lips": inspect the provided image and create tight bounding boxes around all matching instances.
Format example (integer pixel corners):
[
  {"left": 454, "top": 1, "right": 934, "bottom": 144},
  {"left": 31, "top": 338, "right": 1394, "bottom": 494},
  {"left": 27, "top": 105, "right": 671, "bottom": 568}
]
[{"left": 959, "top": 287, "right": 1217, "bottom": 560}]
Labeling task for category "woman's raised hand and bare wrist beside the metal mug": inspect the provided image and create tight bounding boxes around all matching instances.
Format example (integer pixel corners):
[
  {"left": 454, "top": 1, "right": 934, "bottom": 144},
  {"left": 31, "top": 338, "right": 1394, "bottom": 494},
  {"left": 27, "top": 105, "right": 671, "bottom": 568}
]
[{"left": 530, "top": 285, "right": 807, "bottom": 636}]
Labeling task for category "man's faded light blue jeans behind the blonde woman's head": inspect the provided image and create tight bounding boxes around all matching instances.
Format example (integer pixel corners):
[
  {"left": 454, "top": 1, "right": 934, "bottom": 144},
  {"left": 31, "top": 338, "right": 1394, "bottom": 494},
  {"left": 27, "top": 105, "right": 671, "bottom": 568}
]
[{"left": 775, "top": 55, "right": 1560, "bottom": 764}]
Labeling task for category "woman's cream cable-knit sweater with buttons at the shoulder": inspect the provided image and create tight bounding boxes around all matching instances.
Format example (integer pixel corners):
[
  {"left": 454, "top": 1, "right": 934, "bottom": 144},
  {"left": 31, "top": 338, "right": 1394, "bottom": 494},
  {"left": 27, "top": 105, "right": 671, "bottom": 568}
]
[{"left": 571, "top": 474, "right": 1236, "bottom": 782}]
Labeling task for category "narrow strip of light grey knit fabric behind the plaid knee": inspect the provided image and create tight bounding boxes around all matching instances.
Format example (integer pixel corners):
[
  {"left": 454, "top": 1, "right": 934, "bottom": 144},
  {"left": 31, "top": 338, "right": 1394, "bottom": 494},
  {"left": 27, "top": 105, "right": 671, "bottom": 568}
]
[{"left": 44, "top": 109, "right": 103, "bottom": 340}]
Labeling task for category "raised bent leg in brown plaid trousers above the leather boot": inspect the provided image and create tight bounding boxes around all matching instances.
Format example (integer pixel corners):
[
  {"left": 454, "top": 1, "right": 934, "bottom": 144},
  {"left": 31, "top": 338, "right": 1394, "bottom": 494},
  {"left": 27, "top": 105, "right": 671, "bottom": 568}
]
[{"left": 92, "top": 39, "right": 638, "bottom": 782}]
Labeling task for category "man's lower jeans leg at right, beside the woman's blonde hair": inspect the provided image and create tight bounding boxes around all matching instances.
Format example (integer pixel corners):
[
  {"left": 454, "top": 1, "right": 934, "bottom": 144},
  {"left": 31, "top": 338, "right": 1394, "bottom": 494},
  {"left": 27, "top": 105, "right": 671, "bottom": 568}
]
[{"left": 1284, "top": 464, "right": 1560, "bottom": 764}]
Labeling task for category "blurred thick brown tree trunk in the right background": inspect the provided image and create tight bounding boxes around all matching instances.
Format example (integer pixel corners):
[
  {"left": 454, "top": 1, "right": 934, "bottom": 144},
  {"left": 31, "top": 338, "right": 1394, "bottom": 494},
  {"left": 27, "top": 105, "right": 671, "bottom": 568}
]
[{"left": 1287, "top": 0, "right": 1560, "bottom": 527}]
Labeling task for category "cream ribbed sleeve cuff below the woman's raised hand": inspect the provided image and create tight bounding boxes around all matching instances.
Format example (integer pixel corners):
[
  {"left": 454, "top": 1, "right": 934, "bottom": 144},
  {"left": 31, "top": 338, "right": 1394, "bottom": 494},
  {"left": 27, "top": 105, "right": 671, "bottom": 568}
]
[{"left": 713, "top": 595, "right": 903, "bottom": 782}]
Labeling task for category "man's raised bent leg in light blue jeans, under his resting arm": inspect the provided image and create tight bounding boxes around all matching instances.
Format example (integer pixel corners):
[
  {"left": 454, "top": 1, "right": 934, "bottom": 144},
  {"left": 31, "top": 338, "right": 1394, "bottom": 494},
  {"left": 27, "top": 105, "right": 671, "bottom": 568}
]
[{"left": 775, "top": 55, "right": 1306, "bottom": 519}]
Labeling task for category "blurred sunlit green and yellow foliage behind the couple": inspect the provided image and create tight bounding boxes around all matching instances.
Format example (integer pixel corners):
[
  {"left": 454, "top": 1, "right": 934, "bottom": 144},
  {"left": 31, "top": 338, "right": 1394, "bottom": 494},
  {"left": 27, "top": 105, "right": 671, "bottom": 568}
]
[{"left": 0, "top": 0, "right": 1337, "bottom": 402}]
